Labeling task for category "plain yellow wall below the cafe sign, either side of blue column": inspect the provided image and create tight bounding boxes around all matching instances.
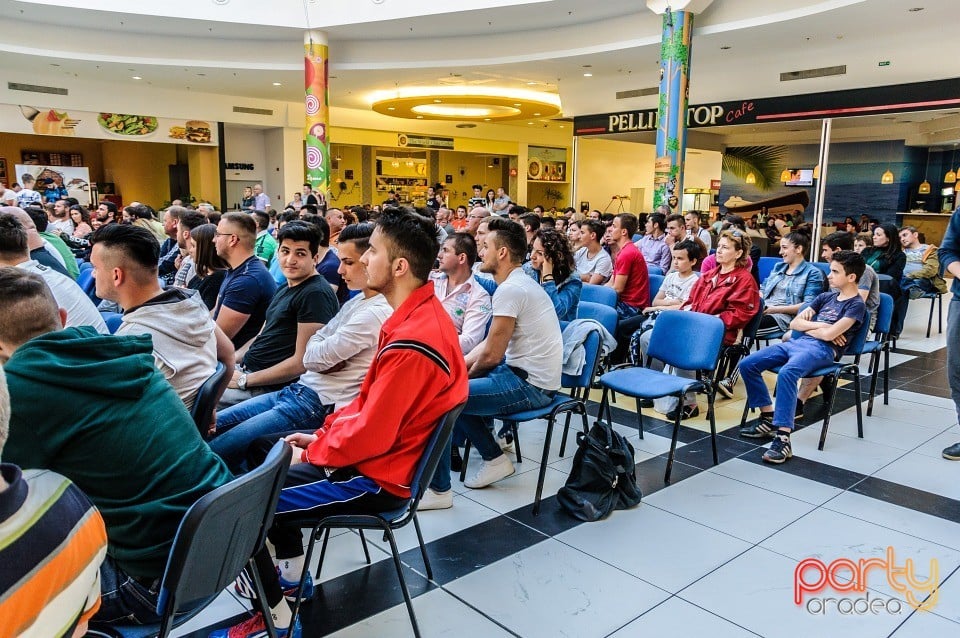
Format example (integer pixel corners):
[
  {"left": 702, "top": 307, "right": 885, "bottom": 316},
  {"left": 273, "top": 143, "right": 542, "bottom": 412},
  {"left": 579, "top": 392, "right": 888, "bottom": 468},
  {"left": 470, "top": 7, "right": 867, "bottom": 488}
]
[{"left": 573, "top": 137, "right": 720, "bottom": 213}]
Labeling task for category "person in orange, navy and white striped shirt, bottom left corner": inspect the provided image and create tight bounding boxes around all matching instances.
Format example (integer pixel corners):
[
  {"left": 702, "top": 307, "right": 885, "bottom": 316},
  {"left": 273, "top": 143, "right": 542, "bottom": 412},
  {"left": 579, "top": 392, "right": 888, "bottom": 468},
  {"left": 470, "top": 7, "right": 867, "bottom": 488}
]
[{"left": 0, "top": 368, "right": 107, "bottom": 637}]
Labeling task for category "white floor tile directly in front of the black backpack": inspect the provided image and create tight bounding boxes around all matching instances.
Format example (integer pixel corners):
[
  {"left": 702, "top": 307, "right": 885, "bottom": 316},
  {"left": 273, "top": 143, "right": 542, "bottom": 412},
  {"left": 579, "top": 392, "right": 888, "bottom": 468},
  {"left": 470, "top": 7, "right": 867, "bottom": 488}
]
[{"left": 556, "top": 503, "right": 751, "bottom": 592}]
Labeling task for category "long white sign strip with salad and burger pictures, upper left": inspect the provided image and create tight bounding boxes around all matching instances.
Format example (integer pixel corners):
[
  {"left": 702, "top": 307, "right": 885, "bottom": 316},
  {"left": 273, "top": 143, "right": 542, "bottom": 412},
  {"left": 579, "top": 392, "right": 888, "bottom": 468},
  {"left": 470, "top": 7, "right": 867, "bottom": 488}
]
[{"left": 0, "top": 104, "right": 219, "bottom": 146}]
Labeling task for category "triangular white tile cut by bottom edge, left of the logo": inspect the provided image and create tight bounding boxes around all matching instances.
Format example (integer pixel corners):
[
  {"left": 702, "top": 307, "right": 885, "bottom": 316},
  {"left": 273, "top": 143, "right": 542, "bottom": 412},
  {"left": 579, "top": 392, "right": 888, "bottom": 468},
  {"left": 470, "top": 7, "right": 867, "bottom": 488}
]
[{"left": 610, "top": 598, "right": 756, "bottom": 638}]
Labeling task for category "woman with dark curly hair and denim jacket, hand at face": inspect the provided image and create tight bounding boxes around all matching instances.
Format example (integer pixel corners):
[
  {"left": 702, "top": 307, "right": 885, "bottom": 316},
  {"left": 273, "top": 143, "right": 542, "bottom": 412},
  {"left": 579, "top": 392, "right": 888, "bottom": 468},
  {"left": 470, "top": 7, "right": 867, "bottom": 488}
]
[{"left": 528, "top": 228, "right": 583, "bottom": 321}]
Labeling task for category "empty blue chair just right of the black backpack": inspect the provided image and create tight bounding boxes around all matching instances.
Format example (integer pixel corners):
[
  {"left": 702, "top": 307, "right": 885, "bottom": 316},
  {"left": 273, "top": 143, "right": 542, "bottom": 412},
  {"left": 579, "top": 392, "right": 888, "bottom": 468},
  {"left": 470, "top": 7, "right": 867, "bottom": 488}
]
[{"left": 598, "top": 310, "right": 724, "bottom": 483}]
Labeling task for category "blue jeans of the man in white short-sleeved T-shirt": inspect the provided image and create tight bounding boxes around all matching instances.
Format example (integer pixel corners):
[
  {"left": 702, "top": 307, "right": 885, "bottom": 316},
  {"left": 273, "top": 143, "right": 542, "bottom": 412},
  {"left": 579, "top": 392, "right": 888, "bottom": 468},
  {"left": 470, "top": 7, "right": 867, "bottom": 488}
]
[{"left": 430, "top": 363, "right": 555, "bottom": 492}]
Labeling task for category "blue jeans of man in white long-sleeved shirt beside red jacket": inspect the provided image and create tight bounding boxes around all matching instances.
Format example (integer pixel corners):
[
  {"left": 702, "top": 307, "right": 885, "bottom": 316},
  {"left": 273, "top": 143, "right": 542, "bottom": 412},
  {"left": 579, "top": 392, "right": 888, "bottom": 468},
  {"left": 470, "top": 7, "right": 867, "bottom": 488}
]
[{"left": 210, "top": 383, "right": 329, "bottom": 468}]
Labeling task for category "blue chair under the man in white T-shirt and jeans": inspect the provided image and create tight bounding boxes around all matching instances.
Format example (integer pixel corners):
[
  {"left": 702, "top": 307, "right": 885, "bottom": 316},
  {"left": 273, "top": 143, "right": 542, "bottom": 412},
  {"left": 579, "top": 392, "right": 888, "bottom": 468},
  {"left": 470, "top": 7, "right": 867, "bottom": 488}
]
[{"left": 460, "top": 328, "right": 604, "bottom": 516}]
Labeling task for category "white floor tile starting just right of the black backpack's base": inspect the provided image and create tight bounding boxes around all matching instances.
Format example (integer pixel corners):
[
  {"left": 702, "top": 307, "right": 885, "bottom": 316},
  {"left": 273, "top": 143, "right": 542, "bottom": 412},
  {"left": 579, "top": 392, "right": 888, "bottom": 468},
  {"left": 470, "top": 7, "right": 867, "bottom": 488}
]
[{"left": 646, "top": 472, "right": 813, "bottom": 543}]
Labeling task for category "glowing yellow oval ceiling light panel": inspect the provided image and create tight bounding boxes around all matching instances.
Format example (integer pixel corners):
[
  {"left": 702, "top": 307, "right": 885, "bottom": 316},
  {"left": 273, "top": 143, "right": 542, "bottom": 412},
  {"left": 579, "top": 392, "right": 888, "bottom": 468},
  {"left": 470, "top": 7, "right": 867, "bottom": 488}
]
[{"left": 369, "top": 86, "right": 560, "bottom": 122}]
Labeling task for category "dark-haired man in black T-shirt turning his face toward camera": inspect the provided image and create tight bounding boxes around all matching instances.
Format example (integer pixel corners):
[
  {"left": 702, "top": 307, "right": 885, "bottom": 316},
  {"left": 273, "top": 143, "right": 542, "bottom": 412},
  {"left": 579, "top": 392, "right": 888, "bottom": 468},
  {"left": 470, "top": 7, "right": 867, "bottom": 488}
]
[{"left": 220, "top": 222, "right": 340, "bottom": 407}]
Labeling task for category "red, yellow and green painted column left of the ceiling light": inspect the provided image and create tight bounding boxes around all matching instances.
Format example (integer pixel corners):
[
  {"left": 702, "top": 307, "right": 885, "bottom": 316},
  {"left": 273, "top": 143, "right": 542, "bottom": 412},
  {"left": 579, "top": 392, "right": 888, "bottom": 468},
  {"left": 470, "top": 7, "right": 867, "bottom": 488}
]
[{"left": 303, "top": 31, "right": 330, "bottom": 196}]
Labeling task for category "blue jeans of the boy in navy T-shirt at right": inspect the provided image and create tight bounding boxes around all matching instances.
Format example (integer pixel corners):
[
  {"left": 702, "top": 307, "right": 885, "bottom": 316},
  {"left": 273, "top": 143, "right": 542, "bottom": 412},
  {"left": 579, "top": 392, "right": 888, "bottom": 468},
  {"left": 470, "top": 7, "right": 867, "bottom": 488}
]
[{"left": 740, "top": 337, "right": 834, "bottom": 430}]
